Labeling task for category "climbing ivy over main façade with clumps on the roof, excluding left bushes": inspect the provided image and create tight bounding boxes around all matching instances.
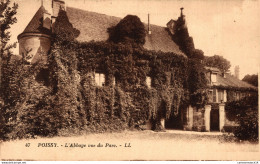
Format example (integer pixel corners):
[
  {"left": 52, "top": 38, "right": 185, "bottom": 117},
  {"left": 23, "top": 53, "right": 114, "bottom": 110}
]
[{"left": 47, "top": 11, "right": 207, "bottom": 131}]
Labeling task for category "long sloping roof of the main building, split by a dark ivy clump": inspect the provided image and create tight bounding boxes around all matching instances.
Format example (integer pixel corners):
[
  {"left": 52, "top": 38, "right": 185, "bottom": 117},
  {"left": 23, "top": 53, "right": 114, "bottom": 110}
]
[{"left": 66, "top": 7, "right": 185, "bottom": 56}]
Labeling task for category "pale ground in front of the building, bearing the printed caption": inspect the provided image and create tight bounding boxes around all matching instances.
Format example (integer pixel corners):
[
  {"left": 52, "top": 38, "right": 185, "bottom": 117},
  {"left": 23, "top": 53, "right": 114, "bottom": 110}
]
[{"left": 0, "top": 130, "right": 260, "bottom": 160}]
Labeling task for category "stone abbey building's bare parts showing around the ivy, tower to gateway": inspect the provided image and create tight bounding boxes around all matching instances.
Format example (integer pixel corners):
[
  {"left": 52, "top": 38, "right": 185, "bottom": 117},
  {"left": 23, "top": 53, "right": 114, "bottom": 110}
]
[{"left": 18, "top": 0, "right": 256, "bottom": 131}]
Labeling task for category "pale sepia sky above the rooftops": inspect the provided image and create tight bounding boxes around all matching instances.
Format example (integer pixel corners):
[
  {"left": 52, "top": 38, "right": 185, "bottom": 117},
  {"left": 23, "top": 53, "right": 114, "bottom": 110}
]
[{"left": 7, "top": 0, "right": 260, "bottom": 79}]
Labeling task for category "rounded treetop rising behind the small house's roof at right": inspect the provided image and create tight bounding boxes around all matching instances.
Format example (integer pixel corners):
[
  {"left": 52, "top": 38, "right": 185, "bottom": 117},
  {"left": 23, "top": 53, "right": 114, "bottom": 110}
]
[{"left": 204, "top": 55, "right": 231, "bottom": 72}]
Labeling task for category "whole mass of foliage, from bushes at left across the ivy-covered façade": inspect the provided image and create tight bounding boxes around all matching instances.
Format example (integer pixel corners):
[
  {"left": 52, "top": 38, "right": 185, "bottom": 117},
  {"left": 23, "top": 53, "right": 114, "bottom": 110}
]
[{"left": 0, "top": 8, "right": 209, "bottom": 138}]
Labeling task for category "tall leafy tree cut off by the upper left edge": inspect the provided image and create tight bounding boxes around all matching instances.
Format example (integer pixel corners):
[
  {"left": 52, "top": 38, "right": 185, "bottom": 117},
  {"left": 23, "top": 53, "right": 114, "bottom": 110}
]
[{"left": 0, "top": 0, "right": 18, "bottom": 87}]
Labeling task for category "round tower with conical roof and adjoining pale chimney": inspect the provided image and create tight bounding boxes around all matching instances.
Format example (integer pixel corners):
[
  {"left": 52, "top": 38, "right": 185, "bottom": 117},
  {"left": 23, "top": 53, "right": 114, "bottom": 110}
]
[{"left": 17, "top": 0, "right": 65, "bottom": 63}]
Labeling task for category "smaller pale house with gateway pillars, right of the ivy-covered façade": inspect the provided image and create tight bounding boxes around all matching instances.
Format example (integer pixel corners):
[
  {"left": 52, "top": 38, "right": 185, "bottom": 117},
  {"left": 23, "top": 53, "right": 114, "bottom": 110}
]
[{"left": 184, "top": 67, "right": 257, "bottom": 131}]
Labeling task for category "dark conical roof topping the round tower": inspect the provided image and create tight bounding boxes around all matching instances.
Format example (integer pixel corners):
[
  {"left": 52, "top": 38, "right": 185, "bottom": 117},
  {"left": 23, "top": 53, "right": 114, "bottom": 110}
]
[{"left": 18, "top": 6, "right": 51, "bottom": 38}]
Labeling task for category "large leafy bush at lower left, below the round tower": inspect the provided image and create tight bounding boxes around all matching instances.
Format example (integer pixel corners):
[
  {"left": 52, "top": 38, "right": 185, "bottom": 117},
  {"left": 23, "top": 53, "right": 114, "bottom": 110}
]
[{"left": 9, "top": 79, "right": 59, "bottom": 139}]
